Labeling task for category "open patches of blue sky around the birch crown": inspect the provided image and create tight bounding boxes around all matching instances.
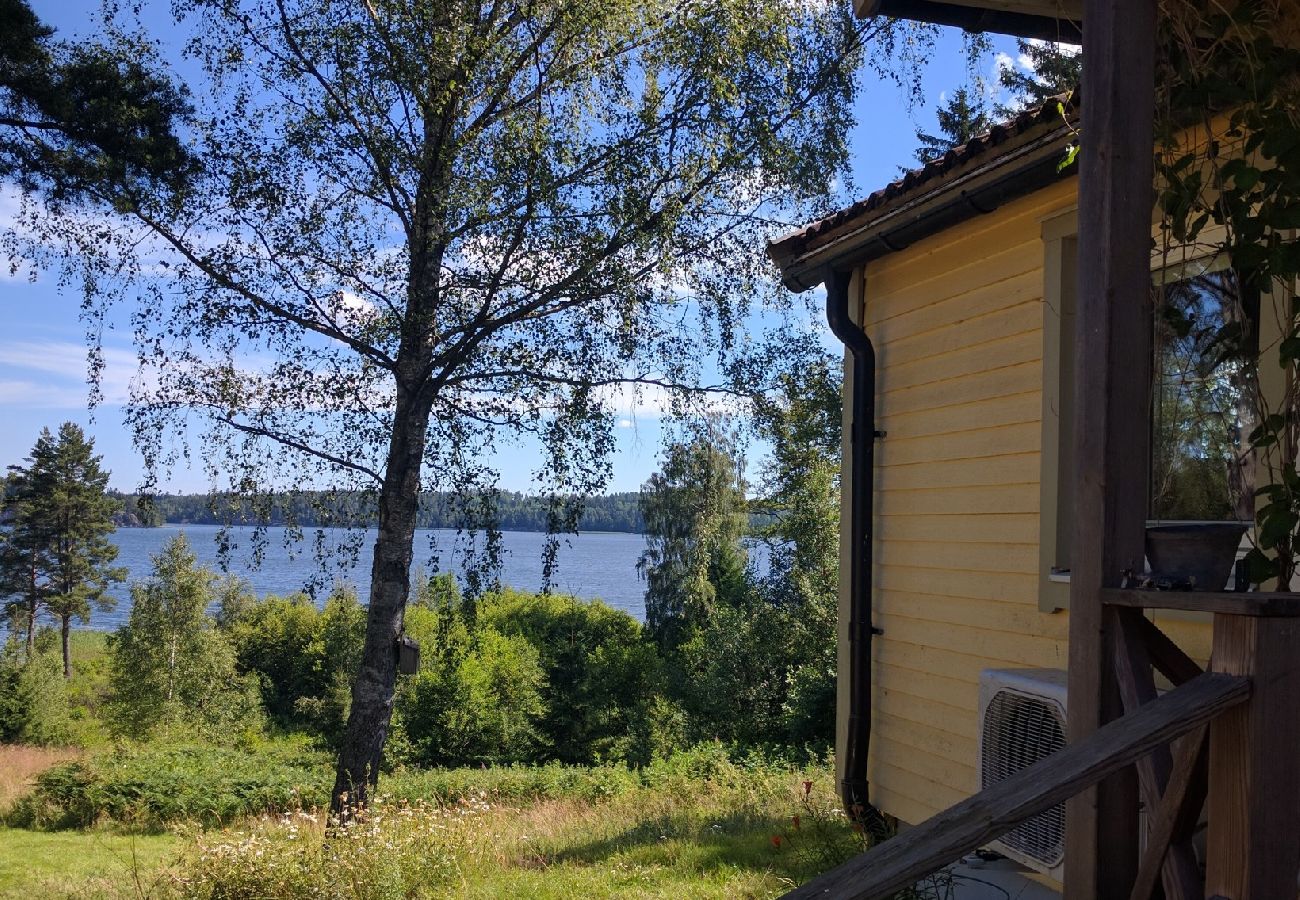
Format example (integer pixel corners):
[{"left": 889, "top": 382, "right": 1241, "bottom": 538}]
[{"left": 0, "top": 0, "right": 1015, "bottom": 492}]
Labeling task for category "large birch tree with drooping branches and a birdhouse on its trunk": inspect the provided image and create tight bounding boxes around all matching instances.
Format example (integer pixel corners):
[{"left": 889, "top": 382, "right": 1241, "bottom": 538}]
[{"left": 7, "top": 0, "right": 925, "bottom": 813}]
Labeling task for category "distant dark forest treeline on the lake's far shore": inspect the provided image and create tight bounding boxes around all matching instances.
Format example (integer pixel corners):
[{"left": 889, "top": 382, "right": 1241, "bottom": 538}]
[{"left": 113, "top": 490, "right": 645, "bottom": 535}]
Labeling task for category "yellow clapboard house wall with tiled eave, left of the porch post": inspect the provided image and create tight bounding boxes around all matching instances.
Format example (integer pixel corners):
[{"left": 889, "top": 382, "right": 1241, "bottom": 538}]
[{"left": 770, "top": 84, "right": 1279, "bottom": 894}]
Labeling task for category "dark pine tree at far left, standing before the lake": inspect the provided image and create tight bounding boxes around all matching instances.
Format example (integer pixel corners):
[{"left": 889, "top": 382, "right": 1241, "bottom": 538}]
[{"left": 0, "top": 421, "right": 126, "bottom": 678}]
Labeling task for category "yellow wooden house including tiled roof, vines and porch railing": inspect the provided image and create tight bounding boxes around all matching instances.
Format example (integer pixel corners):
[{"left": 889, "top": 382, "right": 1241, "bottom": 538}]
[{"left": 770, "top": 0, "right": 1300, "bottom": 900}]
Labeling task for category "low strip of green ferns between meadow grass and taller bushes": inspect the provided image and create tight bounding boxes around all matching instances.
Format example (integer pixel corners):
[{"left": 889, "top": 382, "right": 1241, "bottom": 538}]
[{"left": 8, "top": 739, "right": 792, "bottom": 828}]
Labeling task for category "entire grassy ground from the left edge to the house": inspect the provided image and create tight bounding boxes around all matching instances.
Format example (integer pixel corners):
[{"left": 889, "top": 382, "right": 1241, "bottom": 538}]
[{"left": 0, "top": 747, "right": 855, "bottom": 900}]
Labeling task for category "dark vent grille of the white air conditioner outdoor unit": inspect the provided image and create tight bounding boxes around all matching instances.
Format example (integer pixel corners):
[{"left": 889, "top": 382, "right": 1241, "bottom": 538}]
[{"left": 980, "top": 691, "right": 1065, "bottom": 867}]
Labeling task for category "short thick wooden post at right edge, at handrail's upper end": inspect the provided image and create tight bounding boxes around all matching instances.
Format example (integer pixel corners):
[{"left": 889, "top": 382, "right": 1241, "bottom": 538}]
[{"left": 1205, "top": 614, "right": 1300, "bottom": 900}]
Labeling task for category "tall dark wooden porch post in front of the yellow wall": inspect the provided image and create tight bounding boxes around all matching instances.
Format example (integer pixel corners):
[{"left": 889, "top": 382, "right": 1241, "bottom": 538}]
[{"left": 1065, "top": 0, "right": 1156, "bottom": 900}]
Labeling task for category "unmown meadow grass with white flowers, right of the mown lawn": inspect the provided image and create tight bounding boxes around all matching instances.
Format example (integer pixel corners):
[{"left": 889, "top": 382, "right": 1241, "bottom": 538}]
[{"left": 173, "top": 771, "right": 832, "bottom": 900}]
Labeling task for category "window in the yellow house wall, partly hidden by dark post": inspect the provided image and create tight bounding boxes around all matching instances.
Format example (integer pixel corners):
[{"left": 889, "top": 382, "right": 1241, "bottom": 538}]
[{"left": 1039, "top": 212, "right": 1260, "bottom": 611}]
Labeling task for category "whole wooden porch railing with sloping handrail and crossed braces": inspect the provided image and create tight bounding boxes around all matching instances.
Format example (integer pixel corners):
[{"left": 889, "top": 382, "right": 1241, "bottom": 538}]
[{"left": 787, "top": 598, "right": 1300, "bottom": 900}]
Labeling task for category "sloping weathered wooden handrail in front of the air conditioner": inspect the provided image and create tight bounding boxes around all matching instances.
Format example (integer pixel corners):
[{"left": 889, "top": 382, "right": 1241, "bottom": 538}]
[{"left": 785, "top": 674, "right": 1251, "bottom": 900}]
